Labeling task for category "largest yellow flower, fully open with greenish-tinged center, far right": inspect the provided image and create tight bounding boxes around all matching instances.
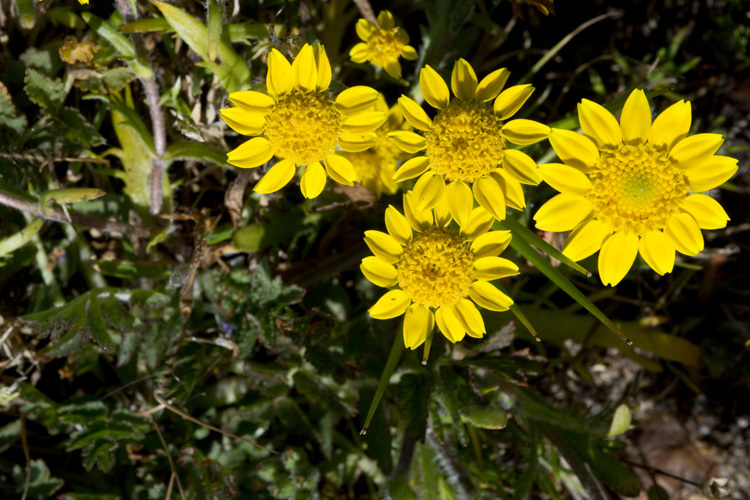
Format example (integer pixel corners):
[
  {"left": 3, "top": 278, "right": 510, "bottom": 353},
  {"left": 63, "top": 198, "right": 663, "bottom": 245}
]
[{"left": 534, "top": 90, "right": 737, "bottom": 286}]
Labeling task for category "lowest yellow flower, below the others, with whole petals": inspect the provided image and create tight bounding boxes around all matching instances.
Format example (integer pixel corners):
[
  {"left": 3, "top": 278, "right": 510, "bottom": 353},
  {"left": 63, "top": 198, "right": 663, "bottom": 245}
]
[{"left": 360, "top": 191, "right": 518, "bottom": 349}]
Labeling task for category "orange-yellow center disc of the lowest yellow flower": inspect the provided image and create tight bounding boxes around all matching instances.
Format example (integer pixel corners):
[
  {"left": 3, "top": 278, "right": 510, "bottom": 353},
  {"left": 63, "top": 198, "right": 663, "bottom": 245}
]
[{"left": 397, "top": 227, "right": 475, "bottom": 308}]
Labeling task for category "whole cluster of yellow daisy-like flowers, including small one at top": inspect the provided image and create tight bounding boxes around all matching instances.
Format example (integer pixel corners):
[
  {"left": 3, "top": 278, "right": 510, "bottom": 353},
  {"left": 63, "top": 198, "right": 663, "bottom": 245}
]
[{"left": 221, "top": 11, "right": 737, "bottom": 356}]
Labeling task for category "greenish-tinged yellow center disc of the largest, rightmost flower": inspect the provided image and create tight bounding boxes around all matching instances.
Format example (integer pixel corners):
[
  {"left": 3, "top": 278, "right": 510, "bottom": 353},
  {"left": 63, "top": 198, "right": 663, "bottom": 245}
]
[{"left": 588, "top": 143, "right": 688, "bottom": 235}]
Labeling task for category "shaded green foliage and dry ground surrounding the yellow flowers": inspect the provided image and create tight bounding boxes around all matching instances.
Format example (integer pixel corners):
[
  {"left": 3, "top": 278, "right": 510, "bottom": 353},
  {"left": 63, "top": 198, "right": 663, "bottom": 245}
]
[{"left": 0, "top": 0, "right": 750, "bottom": 499}]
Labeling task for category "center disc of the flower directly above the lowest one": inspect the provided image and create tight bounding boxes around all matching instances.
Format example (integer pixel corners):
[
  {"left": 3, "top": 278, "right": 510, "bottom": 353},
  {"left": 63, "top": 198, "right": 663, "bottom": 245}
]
[{"left": 426, "top": 99, "right": 505, "bottom": 184}]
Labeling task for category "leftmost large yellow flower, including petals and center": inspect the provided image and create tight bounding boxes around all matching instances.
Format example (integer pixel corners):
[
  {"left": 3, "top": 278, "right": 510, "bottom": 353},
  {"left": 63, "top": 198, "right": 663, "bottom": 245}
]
[{"left": 221, "top": 44, "right": 386, "bottom": 198}]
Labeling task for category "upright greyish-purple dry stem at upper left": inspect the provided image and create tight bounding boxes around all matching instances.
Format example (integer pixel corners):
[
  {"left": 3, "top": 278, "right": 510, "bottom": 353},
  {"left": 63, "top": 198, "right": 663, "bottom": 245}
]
[{"left": 115, "top": 0, "right": 167, "bottom": 215}]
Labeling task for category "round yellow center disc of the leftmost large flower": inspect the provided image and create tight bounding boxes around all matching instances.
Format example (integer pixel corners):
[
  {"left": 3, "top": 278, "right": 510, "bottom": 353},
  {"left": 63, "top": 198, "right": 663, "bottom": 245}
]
[{"left": 264, "top": 89, "right": 342, "bottom": 165}]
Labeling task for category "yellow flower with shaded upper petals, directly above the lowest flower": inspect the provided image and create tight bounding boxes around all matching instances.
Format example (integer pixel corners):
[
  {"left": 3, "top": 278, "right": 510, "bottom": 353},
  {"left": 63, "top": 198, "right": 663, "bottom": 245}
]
[{"left": 389, "top": 59, "right": 550, "bottom": 224}]
